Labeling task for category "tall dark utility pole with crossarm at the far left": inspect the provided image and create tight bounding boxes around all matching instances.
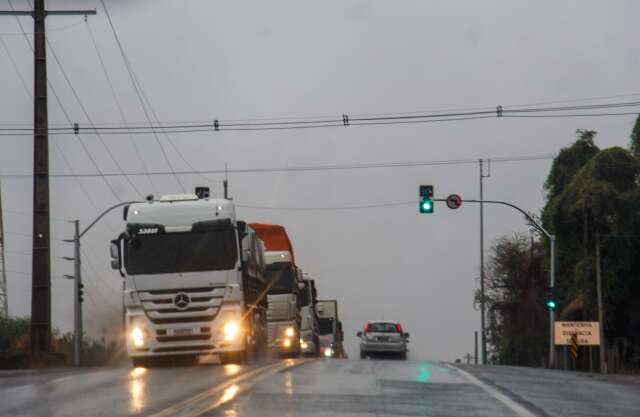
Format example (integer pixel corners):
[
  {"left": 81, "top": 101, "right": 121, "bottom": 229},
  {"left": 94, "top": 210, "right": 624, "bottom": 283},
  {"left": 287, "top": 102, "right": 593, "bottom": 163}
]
[{"left": 0, "top": 0, "right": 96, "bottom": 354}]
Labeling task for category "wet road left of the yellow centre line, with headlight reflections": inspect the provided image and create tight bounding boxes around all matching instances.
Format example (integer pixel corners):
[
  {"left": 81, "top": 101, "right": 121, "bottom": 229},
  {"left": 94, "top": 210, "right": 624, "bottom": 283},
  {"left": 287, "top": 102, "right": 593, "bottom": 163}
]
[{"left": 0, "top": 358, "right": 268, "bottom": 417}]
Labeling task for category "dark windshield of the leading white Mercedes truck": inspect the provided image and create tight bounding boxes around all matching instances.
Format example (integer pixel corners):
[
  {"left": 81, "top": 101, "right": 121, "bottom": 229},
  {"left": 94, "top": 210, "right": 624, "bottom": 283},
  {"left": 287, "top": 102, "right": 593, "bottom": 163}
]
[{"left": 125, "top": 228, "right": 238, "bottom": 275}]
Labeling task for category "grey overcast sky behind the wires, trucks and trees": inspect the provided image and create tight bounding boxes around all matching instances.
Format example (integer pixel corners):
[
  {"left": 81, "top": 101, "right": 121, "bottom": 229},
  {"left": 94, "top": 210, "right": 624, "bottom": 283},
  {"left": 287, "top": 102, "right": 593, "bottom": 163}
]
[{"left": 0, "top": 0, "right": 640, "bottom": 360}]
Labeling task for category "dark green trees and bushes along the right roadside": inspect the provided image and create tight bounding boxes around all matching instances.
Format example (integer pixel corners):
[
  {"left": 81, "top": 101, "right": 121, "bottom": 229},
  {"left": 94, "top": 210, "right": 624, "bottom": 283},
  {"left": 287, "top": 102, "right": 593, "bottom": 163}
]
[{"left": 487, "top": 116, "right": 640, "bottom": 366}]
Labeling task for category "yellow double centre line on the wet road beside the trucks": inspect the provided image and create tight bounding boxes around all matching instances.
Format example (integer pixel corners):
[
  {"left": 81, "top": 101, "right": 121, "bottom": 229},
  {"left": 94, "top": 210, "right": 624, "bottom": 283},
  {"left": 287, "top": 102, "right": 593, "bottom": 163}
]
[{"left": 147, "top": 359, "right": 314, "bottom": 417}]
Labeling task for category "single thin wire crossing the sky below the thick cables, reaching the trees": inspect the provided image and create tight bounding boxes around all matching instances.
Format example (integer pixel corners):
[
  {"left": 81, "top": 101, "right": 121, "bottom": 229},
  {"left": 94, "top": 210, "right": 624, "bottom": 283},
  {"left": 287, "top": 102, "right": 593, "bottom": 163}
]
[{"left": 0, "top": 154, "right": 555, "bottom": 178}]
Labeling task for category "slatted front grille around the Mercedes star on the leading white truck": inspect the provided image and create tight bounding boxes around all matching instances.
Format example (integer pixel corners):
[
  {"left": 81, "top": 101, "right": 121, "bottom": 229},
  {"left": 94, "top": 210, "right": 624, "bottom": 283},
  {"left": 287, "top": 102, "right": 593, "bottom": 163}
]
[{"left": 138, "top": 287, "right": 224, "bottom": 324}]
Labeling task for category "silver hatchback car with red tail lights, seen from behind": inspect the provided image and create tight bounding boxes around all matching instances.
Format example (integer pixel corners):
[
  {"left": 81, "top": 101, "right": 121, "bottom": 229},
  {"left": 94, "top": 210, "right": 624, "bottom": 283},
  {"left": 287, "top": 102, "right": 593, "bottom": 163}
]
[{"left": 357, "top": 321, "right": 409, "bottom": 359}]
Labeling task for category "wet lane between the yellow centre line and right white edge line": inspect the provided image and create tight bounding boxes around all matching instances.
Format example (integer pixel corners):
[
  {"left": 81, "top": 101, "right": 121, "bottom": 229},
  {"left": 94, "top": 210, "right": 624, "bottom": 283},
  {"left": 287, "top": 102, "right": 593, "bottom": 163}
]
[{"left": 205, "top": 360, "right": 518, "bottom": 417}]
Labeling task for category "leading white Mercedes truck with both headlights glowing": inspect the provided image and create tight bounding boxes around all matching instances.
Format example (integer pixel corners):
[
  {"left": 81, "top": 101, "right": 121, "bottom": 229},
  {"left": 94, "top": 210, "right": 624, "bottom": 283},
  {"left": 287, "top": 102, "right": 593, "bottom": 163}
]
[{"left": 111, "top": 187, "right": 267, "bottom": 366}]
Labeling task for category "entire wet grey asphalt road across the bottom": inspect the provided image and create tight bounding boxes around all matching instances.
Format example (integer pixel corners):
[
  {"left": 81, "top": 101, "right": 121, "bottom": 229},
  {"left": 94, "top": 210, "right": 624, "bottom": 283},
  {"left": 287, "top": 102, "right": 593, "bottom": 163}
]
[{"left": 0, "top": 359, "right": 640, "bottom": 417}]
